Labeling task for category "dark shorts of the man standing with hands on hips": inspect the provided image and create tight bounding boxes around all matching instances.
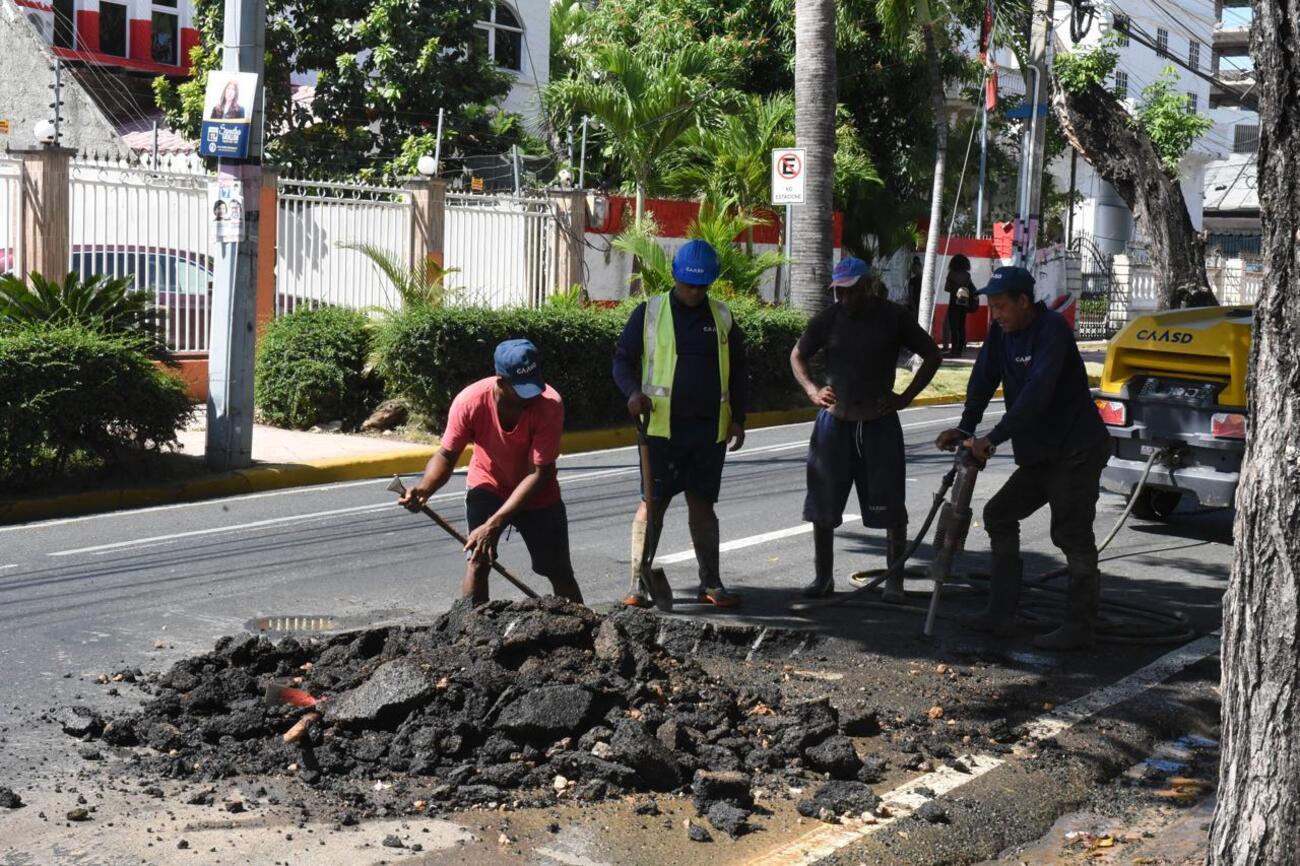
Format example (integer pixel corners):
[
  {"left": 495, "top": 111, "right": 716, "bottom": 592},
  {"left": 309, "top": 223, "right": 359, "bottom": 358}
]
[{"left": 803, "top": 410, "right": 907, "bottom": 529}]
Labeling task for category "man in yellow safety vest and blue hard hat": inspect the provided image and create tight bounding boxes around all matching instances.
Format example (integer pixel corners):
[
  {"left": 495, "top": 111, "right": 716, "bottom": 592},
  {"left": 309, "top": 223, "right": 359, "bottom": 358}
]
[{"left": 614, "top": 241, "right": 748, "bottom": 607}]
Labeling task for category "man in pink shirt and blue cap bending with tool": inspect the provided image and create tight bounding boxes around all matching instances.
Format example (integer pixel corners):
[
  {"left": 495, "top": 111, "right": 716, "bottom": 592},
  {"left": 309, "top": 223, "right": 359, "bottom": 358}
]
[{"left": 400, "top": 339, "right": 582, "bottom": 605}]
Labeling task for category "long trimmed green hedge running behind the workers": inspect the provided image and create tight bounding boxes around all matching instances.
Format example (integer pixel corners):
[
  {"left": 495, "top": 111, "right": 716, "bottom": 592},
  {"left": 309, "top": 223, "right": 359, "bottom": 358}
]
[{"left": 374, "top": 300, "right": 805, "bottom": 429}]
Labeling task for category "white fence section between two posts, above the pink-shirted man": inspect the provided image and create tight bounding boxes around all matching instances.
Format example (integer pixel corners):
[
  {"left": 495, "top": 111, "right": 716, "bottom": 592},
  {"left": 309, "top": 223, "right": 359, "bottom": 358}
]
[{"left": 443, "top": 194, "right": 559, "bottom": 307}]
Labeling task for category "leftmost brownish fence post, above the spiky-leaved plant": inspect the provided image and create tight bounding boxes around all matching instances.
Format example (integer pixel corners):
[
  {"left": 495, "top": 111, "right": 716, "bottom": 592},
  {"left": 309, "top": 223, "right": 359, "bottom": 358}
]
[{"left": 13, "top": 147, "right": 75, "bottom": 280}]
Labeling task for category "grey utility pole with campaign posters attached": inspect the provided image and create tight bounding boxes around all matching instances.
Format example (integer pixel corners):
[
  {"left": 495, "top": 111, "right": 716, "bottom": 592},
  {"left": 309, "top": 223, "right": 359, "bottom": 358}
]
[{"left": 205, "top": 0, "right": 267, "bottom": 472}]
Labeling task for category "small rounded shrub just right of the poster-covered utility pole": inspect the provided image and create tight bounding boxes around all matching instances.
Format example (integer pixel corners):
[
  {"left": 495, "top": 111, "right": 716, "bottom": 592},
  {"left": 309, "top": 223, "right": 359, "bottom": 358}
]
[{"left": 254, "top": 307, "right": 377, "bottom": 429}]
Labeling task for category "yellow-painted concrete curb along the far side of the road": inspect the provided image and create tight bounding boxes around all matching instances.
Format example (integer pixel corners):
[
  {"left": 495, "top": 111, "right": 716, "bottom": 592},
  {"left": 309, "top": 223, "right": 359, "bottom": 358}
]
[{"left": 0, "top": 376, "right": 1097, "bottom": 524}]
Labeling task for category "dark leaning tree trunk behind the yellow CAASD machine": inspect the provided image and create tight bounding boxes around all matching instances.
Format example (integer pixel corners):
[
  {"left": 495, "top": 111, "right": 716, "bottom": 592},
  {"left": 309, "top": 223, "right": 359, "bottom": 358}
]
[{"left": 1048, "top": 75, "right": 1213, "bottom": 309}]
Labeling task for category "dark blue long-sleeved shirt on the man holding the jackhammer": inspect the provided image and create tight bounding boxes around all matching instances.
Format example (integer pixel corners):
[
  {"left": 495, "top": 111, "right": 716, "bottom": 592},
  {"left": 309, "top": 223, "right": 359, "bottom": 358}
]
[{"left": 961, "top": 302, "right": 1108, "bottom": 466}]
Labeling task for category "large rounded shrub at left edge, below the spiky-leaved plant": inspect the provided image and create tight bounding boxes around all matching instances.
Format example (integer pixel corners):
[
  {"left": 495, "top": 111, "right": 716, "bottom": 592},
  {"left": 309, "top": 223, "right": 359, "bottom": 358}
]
[{"left": 0, "top": 322, "right": 191, "bottom": 490}]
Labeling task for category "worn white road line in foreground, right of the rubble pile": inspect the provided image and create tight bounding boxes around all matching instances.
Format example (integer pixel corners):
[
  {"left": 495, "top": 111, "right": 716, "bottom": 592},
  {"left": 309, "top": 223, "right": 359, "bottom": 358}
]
[{"left": 750, "top": 632, "right": 1219, "bottom": 866}]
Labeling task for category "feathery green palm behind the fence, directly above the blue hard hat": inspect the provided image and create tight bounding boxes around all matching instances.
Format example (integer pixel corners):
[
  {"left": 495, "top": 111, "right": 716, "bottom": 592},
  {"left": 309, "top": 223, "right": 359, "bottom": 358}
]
[{"left": 547, "top": 44, "right": 715, "bottom": 222}]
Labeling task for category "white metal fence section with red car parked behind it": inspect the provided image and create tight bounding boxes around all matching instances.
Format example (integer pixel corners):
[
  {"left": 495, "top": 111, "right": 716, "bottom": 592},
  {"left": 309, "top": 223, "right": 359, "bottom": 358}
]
[{"left": 69, "top": 160, "right": 212, "bottom": 352}]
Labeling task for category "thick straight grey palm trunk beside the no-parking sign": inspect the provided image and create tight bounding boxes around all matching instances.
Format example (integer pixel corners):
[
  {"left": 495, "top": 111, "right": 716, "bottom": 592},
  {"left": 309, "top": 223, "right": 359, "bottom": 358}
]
[{"left": 790, "top": 0, "right": 836, "bottom": 315}]
